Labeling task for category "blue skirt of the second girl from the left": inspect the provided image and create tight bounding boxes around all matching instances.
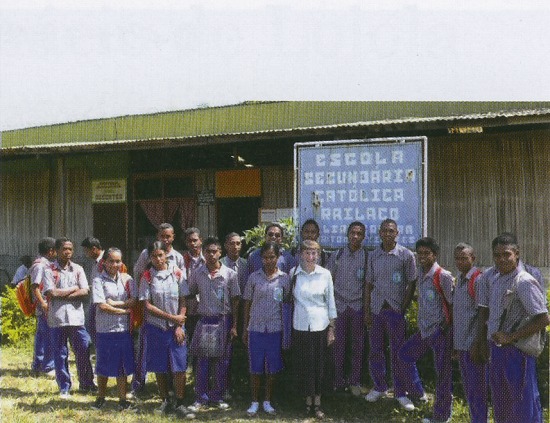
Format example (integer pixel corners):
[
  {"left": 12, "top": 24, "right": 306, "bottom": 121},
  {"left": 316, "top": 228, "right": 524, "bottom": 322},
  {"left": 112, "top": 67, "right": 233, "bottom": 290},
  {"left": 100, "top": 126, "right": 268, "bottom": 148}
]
[{"left": 145, "top": 323, "right": 187, "bottom": 373}]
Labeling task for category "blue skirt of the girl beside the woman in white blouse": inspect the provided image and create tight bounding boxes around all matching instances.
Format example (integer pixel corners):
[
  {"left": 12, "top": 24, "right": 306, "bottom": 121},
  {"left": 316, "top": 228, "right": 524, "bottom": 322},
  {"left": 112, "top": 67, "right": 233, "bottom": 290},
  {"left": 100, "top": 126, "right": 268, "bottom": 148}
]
[{"left": 248, "top": 332, "right": 283, "bottom": 375}]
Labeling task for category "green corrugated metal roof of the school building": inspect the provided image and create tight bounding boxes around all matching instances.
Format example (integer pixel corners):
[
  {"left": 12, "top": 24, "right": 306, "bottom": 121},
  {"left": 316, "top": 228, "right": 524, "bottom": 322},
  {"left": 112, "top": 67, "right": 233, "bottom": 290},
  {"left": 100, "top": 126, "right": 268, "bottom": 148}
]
[{"left": 0, "top": 102, "right": 550, "bottom": 154}]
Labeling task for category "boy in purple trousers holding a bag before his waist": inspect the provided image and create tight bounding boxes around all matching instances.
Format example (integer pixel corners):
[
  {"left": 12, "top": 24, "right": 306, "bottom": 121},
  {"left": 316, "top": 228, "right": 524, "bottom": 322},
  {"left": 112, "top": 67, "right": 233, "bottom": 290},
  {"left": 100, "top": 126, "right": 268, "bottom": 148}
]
[{"left": 188, "top": 237, "right": 241, "bottom": 412}]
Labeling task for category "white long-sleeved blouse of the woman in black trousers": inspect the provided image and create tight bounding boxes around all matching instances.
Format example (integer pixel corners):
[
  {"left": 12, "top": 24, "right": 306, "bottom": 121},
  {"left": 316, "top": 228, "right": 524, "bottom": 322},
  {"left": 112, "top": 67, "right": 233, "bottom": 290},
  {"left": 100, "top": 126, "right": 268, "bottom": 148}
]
[{"left": 290, "top": 265, "right": 336, "bottom": 332}]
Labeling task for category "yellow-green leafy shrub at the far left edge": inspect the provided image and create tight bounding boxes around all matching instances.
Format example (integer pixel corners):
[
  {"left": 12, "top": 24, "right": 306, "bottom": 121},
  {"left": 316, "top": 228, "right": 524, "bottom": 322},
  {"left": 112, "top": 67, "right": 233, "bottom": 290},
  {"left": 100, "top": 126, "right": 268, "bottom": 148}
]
[{"left": 0, "top": 287, "right": 36, "bottom": 345}]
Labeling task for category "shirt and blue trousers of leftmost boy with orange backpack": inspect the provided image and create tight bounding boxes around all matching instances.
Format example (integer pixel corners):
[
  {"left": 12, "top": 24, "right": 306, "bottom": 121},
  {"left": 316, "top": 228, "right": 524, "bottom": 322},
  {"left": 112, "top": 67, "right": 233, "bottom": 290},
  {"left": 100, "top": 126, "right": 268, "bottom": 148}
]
[{"left": 29, "top": 257, "right": 55, "bottom": 373}]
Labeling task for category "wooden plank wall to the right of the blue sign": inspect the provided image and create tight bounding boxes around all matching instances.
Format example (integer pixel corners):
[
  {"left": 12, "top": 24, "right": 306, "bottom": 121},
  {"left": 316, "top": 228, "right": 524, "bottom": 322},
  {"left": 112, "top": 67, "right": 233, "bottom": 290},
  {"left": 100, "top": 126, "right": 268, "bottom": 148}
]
[{"left": 428, "top": 127, "right": 550, "bottom": 268}]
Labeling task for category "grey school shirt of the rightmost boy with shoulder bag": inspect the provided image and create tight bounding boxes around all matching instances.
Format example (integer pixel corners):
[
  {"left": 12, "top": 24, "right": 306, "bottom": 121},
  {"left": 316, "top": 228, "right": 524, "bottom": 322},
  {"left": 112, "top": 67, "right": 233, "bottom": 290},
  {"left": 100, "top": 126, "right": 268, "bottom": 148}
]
[{"left": 487, "top": 267, "right": 548, "bottom": 340}]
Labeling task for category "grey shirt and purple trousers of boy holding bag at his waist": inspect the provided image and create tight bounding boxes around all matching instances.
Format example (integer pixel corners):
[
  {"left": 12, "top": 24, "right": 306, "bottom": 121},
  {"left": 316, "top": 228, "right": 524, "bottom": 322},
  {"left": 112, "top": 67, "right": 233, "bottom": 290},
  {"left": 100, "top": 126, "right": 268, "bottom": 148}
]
[{"left": 188, "top": 264, "right": 241, "bottom": 403}]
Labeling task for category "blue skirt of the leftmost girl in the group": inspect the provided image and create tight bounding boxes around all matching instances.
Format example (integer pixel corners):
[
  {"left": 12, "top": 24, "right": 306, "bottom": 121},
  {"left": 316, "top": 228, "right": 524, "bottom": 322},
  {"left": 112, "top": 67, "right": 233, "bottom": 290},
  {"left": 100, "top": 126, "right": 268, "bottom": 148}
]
[{"left": 95, "top": 332, "right": 135, "bottom": 377}]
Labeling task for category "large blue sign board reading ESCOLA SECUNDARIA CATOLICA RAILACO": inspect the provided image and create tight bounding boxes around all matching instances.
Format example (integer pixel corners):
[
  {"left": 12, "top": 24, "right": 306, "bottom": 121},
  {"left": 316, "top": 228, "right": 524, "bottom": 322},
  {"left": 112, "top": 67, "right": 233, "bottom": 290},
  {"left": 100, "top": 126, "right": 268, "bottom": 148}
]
[{"left": 295, "top": 137, "right": 426, "bottom": 248}]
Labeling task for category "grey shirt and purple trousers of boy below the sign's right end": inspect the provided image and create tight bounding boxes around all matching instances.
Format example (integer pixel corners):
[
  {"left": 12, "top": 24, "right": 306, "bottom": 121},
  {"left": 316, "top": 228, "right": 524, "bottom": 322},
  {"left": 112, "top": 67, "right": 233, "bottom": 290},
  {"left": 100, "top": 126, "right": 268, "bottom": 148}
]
[{"left": 366, "top": 244, "right": 424, "bottom": 398}]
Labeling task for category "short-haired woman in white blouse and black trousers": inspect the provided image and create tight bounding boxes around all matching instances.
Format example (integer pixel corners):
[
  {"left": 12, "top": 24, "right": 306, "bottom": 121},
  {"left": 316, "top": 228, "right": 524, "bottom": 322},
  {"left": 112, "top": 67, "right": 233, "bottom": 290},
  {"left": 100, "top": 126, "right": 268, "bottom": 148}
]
[{"left": 290, "top": 240, "right": 336, "bottom": 419}]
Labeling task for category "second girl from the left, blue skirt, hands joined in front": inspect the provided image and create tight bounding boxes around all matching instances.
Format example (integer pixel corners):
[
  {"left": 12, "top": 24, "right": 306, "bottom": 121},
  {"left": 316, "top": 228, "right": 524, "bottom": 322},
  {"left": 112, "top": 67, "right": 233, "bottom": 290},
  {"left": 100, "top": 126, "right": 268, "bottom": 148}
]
[{"left": 139, "top": 241, "right": 195, "bottom": 418}]
